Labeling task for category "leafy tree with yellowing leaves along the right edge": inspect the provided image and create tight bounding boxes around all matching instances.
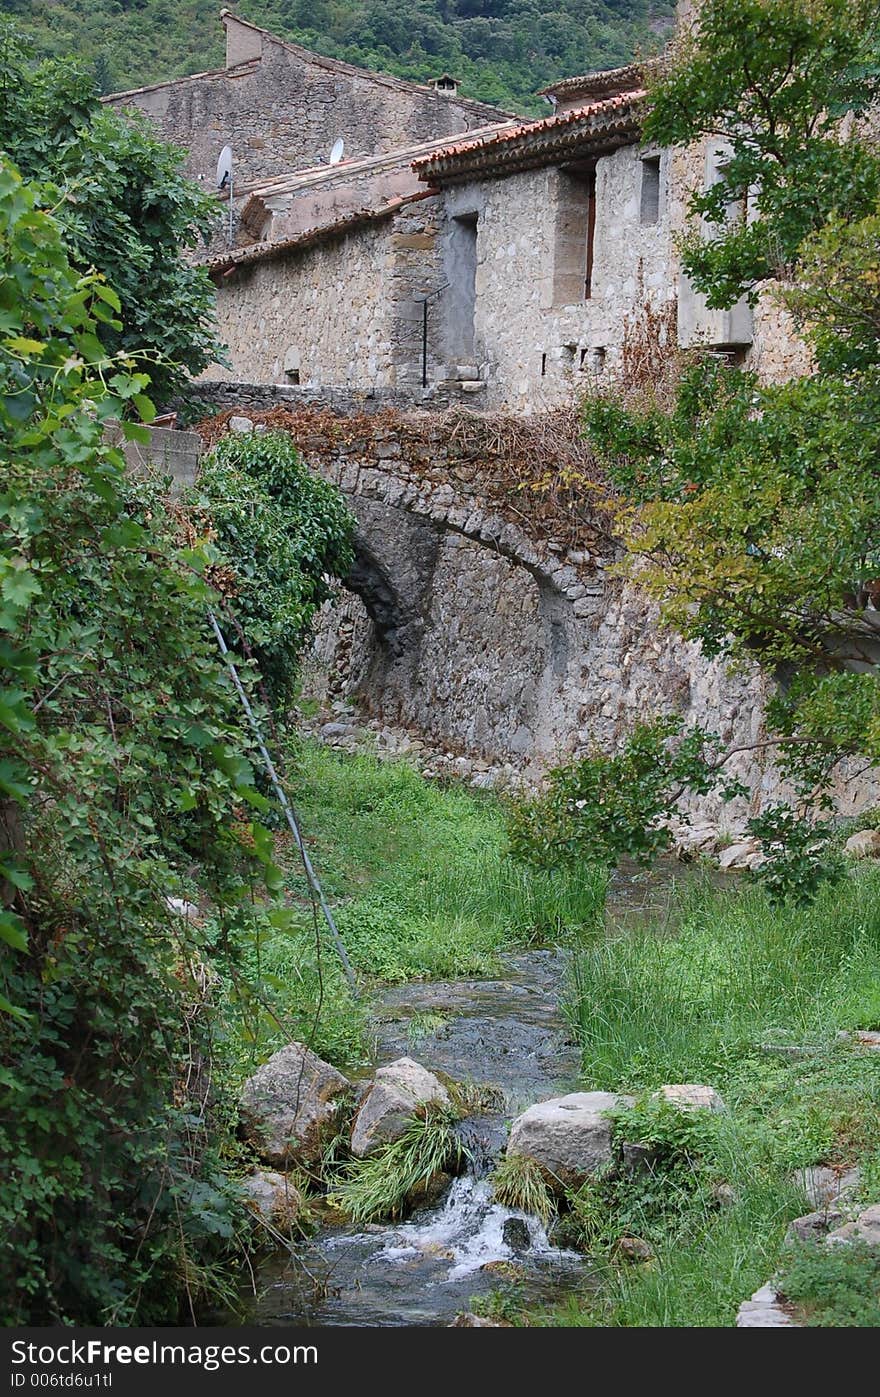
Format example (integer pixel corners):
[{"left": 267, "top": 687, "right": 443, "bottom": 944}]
[{"left": 514, "top": 0, "right": 880, "bottom": 897}]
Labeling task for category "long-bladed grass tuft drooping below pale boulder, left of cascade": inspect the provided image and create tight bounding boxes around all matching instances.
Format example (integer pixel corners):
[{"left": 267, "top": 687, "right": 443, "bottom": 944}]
[{"left": 330, "top": 1108, "right": 464, "bottom": 1224}]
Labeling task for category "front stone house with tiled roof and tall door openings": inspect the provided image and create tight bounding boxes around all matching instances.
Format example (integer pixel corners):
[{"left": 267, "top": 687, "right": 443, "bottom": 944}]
[{"left": 198, "top": 36, "right": 806, "bottom": 414}]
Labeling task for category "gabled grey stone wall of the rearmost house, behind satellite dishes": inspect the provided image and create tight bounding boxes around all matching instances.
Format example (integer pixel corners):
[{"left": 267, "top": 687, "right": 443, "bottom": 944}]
[{"left": 106, "top": 17, "right": 504, "bottom": 190}]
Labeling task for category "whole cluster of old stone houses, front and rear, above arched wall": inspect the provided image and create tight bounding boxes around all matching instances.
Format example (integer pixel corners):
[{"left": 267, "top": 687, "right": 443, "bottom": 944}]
[{"left": 108, "top": 6, "right": 803, "bottom": 414}]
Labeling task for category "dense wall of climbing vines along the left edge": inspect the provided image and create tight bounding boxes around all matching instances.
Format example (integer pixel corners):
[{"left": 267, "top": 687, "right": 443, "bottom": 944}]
[{"left": 0, "top": 155, "right": 352, "bottom": 1324}]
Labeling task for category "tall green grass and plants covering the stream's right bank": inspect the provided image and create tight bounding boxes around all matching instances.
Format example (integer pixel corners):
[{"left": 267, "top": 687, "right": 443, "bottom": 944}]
[{"left": 531, "top": 869, "right": 880, "bottom": 1327}]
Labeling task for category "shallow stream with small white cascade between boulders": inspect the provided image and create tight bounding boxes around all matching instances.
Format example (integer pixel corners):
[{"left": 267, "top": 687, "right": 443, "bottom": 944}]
[{"left": 249, "top": 854, "right": 695, "bottom": 1327}]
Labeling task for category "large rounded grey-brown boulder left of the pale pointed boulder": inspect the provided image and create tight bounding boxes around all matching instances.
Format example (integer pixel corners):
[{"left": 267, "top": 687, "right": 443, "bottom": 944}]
[{"left": 239, "top": 1044, "right": 352, "bottom": 1169}]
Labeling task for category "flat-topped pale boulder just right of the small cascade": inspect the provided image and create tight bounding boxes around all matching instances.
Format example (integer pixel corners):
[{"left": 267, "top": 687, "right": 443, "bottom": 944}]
[{"left": 507, "top": 1091, "right": 633, "bottom": 1190}]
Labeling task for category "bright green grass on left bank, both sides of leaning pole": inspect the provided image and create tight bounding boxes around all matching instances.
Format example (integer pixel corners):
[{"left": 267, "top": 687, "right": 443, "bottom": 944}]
[{"left": 220, "top": 742, "right": 606, "bottom": 1078}]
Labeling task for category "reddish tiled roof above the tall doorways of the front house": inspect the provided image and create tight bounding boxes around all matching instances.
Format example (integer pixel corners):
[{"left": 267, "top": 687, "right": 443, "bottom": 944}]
[{"left": 413, "top": 88, "right": 647, "bottom": 182}]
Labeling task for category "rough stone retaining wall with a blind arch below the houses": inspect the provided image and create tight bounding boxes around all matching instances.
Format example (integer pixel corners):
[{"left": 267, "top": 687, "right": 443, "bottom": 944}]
[{"left": 198, "top": 400, "right": 876, "bottom": 828}]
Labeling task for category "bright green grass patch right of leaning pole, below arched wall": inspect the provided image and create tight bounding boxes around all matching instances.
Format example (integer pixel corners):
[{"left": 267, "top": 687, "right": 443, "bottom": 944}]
[{"left": 291, "top": 745, "right": 608, "bottom": 981}]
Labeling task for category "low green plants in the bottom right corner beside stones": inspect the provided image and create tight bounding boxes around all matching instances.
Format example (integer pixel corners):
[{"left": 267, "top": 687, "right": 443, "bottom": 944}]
[{"left": 777, "top": 1242, "right": 880, "bottom": 1329}]
